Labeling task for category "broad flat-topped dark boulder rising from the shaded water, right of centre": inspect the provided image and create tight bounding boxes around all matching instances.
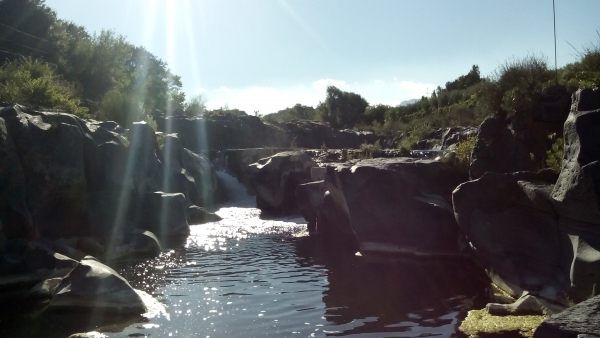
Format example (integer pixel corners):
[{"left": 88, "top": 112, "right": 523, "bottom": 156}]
[{"left": 317, "top": 158, "right": 466, "bottom": 255}]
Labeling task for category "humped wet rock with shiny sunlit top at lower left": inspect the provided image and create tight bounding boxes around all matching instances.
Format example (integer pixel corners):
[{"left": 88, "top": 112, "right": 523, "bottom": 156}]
[{"left": 49, "top": 258, "right": 146, "bottom": 314}]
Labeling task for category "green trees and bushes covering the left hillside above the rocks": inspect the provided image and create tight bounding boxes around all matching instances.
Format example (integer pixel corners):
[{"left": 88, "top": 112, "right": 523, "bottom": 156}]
[{"left": 0, "top": 0, "right": 198, "bottom": 126}]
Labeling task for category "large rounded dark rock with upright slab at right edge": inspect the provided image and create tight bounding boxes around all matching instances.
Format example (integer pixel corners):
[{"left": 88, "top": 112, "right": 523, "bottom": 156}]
[{"left": 453, "top": 90, "right": 600, "bottom": 304}]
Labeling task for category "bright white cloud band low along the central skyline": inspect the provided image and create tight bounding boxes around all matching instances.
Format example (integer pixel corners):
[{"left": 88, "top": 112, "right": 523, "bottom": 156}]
[{"left": 202, "top": 79, "right": 437, "bottom": 115}]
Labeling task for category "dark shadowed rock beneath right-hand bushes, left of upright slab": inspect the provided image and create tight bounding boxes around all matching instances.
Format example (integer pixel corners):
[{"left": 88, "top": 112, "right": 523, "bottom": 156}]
[{"left": 470, "top": 86, "right": 570, "bottom": 179}]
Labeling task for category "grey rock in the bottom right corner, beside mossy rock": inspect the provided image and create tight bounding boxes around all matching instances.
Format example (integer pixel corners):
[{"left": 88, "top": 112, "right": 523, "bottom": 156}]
[{"left": 533, "top": 296, "right": 600, "bottom": 338}]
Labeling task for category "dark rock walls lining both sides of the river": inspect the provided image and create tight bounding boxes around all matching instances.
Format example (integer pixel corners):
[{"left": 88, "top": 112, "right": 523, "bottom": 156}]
[{"left": 0, "top": 90, "right": 600, "bottom": 337}]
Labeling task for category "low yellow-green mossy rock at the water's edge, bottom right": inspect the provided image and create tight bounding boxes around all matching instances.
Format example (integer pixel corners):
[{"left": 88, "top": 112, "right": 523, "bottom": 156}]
[{"left": 458, "top": 309, "right": 546, "bottom": 338}]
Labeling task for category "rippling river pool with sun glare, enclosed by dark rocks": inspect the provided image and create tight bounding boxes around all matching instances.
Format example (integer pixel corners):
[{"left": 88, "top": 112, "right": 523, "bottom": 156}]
[{"left": 1, "top": 173, "right": 485, "bottom": 338}]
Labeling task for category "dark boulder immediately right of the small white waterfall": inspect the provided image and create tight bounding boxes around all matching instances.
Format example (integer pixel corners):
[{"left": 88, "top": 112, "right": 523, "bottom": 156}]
[{"left": 248, "top": 151, "right": 317, "bottom": 211}]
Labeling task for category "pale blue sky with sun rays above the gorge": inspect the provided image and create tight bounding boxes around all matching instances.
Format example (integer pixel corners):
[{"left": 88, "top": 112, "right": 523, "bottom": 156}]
[{"left": 45, "top": 0, "right": 600, "bottom": 115}]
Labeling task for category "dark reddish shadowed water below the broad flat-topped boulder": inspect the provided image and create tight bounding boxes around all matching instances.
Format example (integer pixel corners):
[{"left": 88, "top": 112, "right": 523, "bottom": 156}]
[{"left": 295, "top": 237, "right": 489, "bottom": 337}]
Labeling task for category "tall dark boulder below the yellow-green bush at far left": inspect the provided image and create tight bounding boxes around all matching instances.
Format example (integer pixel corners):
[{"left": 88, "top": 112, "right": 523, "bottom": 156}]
[{"left": 0, "top": 105, "right": 89, "bottom": 238}]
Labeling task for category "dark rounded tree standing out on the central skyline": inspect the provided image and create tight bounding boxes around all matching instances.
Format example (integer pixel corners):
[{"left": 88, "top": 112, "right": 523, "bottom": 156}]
[{"left": 317, "top": 86, "right": 369, "bottom": 128}]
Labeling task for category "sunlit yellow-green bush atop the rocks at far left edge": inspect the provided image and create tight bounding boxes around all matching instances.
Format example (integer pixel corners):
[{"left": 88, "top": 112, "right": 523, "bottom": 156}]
[{"left": 0, "top": 58, "right": 88, "bottom": 117}]
